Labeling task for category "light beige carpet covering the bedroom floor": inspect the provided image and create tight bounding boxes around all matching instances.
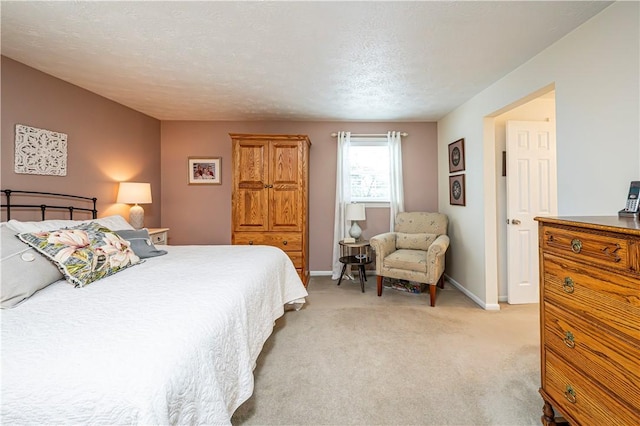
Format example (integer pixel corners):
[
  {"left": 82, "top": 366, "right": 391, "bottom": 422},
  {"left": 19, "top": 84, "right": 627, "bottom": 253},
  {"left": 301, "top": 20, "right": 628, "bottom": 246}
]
[{"left": 232, "top": 277, "right": 543, "bottom": 426}]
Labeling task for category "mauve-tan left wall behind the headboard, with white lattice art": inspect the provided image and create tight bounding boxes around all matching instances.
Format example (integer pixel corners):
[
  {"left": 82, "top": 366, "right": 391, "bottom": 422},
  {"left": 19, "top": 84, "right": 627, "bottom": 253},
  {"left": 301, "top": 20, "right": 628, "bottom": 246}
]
[{"left": 0, "top": 56, "right": 161, "bottom": 226}]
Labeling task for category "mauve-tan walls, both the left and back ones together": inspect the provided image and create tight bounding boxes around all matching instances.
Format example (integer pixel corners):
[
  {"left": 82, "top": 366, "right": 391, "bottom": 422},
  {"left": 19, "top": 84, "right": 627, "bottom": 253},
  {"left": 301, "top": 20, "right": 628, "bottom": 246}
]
[{"left": 0, "top": 57, "right": 438, "bottom": 271}]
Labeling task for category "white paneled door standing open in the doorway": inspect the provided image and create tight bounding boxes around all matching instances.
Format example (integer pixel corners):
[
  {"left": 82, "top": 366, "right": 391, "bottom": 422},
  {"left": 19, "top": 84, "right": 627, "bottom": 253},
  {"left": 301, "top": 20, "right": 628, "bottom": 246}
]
[{"left": 507, "top": 121, "right": 558, "bottom": 303}]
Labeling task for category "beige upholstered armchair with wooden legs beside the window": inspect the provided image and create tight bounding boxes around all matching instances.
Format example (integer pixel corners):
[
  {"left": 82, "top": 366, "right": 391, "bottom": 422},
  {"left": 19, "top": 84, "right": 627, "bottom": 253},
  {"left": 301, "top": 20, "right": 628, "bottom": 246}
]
[{"left": 370, "top": 212, "right": 449, "bottom": 306}]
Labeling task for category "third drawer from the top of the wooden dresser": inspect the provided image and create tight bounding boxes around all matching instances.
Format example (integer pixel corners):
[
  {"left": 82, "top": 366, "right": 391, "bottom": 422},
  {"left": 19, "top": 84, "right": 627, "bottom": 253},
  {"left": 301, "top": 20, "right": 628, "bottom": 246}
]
[{"left": 544, "top": 302, "right": 640, "bottom": 407}]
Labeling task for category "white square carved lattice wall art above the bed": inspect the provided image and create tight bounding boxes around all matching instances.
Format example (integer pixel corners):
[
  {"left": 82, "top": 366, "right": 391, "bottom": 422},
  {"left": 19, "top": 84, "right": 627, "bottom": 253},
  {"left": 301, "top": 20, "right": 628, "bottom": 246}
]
[{"left": 14, "top": 124, "right": 67, "bottom": 176}]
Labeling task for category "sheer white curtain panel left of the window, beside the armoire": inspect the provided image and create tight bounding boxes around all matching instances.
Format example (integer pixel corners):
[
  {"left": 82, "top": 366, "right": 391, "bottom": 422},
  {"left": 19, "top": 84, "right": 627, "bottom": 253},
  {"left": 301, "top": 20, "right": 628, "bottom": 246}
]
[{"left": 331, "top": 132, "right": 351, "bottom": 280}]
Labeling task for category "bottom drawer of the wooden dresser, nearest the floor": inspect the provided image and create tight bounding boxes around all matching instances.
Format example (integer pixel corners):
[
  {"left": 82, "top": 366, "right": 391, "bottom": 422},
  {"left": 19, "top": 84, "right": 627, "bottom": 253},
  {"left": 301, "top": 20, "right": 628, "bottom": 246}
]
[{"left": 542, "top": 349, "right": 638, "bottom": 426}]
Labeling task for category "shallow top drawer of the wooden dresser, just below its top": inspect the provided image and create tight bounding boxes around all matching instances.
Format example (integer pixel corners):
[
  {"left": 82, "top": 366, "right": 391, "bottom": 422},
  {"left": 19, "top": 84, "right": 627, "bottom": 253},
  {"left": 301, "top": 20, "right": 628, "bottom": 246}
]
[{"left": 541, "top": 226, "right": 638, "bottom": 273}]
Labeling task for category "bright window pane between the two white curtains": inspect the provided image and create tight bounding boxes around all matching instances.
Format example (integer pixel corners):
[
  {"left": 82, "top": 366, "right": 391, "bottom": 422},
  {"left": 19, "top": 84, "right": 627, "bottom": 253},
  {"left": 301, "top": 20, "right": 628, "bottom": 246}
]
[{"left": 349, "top": 138, "right": 391, "bottom": 203}]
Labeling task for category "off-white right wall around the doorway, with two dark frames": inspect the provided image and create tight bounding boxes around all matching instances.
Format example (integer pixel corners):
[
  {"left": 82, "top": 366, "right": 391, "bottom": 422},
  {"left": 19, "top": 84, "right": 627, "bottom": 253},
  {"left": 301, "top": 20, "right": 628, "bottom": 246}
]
[{"left": 438, "top": 2, "right": 640, "bottom": 309}]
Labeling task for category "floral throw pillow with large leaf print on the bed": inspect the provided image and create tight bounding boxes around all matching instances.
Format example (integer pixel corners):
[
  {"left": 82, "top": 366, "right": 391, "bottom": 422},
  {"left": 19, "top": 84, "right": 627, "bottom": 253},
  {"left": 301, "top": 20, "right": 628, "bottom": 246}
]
[{"left": 18, "top": 222, "right": 140, "bottom": 287}]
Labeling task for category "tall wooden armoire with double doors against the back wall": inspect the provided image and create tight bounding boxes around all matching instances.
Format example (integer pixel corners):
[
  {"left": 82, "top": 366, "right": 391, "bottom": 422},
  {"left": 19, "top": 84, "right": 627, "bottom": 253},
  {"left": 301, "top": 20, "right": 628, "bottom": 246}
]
[{"left": 229, "top": 133, "right": 311, "bottom": 286}]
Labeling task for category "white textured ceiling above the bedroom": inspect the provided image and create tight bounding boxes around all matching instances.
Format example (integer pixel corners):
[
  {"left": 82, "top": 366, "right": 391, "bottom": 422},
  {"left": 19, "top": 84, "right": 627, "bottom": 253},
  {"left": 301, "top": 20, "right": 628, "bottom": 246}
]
[{"left": 0, "top": 1, "right": 611, "bottom": 121}]
